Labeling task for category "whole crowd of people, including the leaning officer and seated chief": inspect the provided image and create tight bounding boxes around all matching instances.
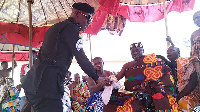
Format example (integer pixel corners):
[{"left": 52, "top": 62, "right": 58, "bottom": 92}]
[{"left": 0, "top": 3, "right": 200, "bottom": 112}]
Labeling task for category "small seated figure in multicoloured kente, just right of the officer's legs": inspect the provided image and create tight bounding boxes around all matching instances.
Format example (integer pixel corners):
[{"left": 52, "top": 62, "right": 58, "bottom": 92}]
[{"left": 69, "top": 73, "right": 90, "bottom": 112}]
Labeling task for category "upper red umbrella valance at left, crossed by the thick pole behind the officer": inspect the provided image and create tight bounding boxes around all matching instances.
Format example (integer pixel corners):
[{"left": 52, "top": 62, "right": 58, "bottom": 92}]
[{"left": 0, "top": 21, "right": 50, "bottom": 47}]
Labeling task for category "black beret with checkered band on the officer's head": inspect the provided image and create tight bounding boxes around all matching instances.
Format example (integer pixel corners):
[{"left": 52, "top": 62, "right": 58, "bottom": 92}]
[{"left": 72, "top": 2, "right": 94, "bottom": 14}]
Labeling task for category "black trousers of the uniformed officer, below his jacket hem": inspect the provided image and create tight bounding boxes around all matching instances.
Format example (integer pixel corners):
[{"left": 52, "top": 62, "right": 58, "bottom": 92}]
[{"left": 26, "top": 93, "right": 63, "bottom": 112}]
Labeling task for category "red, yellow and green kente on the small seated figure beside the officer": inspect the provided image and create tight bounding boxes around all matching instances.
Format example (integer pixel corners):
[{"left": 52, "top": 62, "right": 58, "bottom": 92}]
[{"left": 72, "top": 82, "right": 90, "bottom": 112}]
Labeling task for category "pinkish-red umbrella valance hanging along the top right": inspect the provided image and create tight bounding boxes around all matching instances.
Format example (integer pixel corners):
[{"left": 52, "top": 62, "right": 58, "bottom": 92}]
[{"left": 85, "top": 0, "right": 195, "bottom": 35}]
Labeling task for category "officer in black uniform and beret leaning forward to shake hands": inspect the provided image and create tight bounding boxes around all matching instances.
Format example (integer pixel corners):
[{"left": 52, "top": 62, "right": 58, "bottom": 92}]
[{"left": 22, "top": 3, "right": 107, "bottom": 112}]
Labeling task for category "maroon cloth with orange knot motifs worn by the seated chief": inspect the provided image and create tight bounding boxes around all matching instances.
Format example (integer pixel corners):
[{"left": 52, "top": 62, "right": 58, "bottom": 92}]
[{"left": 104, "top": 53, "right": 178, "bottom": 112}]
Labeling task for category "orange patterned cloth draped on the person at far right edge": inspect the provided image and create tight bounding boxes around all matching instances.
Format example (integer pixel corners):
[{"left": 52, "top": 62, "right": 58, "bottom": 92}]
[{"left": 176, "top": 57, "right": 200, "bottom": 112}]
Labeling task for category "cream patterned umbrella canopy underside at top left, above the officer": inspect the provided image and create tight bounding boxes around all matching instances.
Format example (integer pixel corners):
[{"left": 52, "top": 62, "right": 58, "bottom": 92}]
[{"left": 0, "top": 0, "right": 99, "bottom": 27}]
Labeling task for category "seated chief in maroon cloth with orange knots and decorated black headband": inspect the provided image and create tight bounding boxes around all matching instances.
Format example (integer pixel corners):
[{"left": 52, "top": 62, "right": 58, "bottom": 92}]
[{"left": 104, "top": 42, "right": 178, "bottom": 112}]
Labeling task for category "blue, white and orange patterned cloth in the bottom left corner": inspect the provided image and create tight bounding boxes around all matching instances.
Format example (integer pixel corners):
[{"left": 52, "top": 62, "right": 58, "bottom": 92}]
[{"left": 2, "top": 87, "right": 20, "bottom": 112}]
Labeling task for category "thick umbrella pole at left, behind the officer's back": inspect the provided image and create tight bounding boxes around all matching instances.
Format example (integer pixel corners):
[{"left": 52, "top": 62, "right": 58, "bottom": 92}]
[{"left": 27, "top": 0, "right": 33, "bottom": 68}]
